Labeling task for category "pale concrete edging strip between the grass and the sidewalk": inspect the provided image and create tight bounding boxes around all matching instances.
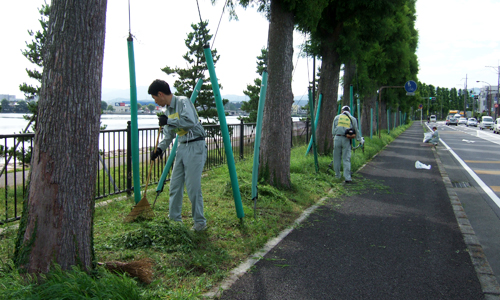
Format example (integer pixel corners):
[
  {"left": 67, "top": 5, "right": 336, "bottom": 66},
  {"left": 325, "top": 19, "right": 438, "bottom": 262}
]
[{"left": 203, "top": 195, "right": 331, "bottom": 298}]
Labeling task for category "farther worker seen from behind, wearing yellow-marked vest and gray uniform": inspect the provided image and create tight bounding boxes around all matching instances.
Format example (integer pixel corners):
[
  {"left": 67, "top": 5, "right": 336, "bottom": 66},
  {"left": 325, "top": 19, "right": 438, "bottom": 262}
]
[{"left": 332, "top": 106, "right": 365, "bottom": 183}]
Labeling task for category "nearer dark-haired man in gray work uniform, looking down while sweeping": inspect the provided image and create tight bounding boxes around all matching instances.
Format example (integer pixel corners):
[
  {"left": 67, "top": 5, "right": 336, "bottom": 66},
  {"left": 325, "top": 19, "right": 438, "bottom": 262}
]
[{"left": 148, "top": 79, "right": 207, "bottom": 231}]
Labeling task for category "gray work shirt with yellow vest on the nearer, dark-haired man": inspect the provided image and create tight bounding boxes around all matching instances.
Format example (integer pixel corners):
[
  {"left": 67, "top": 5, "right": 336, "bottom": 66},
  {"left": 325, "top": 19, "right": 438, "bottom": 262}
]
[{"left": 158, "top": 95, "right": 205, "bottom": 152}]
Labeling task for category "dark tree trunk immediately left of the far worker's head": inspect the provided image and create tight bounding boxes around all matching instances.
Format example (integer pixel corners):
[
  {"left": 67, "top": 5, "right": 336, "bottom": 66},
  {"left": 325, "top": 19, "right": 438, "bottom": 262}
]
[{"left": 316, "top": 35, "right": 340, "bottom": 155}]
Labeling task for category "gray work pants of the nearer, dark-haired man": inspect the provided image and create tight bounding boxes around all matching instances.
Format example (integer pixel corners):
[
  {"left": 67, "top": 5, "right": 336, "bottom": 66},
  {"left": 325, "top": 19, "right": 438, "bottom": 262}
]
[{"left": 169, "top": 140, "right": 207, "bottom": 225}]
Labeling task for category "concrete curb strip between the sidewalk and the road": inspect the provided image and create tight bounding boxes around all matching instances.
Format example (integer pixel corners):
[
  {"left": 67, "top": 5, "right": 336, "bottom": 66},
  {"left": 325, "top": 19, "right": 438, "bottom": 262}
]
[{"left": 432, "top": 148, "right": 500, "bottom": 299}]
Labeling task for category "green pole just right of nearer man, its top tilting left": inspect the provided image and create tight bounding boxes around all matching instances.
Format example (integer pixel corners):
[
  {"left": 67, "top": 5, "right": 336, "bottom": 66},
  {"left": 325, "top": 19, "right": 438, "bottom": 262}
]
[{"left": 203, "top": 44, "right": 245, "bottom": 219}]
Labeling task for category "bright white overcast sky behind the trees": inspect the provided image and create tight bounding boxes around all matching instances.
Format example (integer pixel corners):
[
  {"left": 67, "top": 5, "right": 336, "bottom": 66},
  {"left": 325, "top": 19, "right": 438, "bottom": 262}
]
[{"left": 0, "top": 0, "right": 500, "bottom": 100}]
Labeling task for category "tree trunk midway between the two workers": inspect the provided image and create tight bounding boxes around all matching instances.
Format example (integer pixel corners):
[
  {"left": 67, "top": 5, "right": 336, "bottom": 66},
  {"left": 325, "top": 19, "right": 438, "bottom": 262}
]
[{"left": 260, "top": 0, "right": 294, "bottom": 188}]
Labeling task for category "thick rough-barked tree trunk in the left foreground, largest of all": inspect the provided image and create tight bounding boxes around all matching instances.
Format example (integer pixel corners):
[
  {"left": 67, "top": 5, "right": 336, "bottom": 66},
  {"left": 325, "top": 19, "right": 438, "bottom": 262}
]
[{"left": 15, "top": 0, "right": 107, "bottom": 274}]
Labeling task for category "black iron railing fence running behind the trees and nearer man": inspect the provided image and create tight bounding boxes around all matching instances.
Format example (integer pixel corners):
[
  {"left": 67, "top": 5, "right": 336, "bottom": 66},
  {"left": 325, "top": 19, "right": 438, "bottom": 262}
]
[{"left": 0, "top": 121, "right": 310, "bottom": 225}]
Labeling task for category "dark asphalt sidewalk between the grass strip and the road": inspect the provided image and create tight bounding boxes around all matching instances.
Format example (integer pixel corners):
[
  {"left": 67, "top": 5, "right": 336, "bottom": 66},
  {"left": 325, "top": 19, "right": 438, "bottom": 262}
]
[{"left": 212, "top": 122, "right": 500, "bottom": 299}]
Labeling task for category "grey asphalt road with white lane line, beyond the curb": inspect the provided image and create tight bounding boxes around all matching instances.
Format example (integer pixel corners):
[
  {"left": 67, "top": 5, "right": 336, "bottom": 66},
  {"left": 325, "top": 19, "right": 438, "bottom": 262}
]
[{"left": 431, "top": 122, "right": 500, "bottom": 282}]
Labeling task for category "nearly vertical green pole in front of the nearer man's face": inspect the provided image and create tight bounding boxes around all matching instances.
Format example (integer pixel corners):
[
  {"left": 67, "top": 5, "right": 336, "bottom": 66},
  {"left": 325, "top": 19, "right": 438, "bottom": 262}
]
[{"left": 127, "top": 35, "right": 141, "bottom": 204}]
